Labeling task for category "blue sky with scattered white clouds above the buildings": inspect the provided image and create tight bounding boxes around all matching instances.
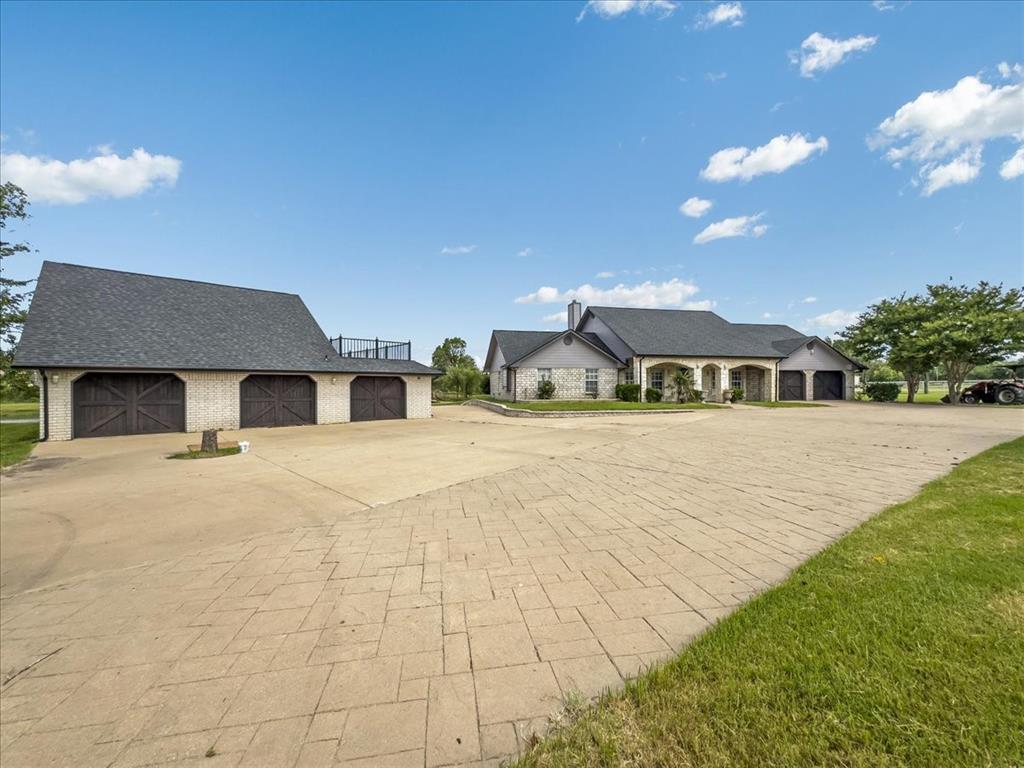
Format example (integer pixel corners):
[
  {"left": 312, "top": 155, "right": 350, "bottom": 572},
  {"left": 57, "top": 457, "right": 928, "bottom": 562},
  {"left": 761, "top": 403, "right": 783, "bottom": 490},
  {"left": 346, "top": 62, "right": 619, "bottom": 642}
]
[{"left": 0, "top": 0, "right": 1024, "bottom": 359}]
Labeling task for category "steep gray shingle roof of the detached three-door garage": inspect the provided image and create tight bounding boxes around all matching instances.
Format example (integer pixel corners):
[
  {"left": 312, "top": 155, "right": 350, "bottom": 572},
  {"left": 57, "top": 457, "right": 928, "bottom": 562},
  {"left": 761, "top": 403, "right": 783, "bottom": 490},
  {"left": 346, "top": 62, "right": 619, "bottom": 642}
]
[{"left": 14, "top": 261, "right": 437, "bottom": 375}]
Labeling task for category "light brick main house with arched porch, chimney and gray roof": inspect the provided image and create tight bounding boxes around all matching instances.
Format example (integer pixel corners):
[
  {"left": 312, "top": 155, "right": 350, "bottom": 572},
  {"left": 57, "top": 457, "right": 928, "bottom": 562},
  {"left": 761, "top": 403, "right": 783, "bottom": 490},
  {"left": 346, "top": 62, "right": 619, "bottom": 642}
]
[{"left": 484, "top": 301, "right": 864, "bottom": 402}]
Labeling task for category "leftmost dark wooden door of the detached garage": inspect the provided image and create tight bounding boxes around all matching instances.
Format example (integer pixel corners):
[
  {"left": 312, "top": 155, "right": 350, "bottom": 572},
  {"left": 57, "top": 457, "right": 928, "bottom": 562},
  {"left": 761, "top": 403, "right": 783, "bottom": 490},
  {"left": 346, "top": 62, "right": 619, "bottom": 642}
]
[{"left": 72, "top": 374, "right": 185, "bottom": 437}]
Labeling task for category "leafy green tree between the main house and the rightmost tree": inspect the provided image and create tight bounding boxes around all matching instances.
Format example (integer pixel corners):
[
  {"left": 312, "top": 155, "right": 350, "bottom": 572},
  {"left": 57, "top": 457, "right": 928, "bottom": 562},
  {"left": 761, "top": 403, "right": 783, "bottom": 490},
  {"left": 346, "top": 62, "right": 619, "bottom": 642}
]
[{"left": 840, "top": 295, "right": 938, "bottom": 402}]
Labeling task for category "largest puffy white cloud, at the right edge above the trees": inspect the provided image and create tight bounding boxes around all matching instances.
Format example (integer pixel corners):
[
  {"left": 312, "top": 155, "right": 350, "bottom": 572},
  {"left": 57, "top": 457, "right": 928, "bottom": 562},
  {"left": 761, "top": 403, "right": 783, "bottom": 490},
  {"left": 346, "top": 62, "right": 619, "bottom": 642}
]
[{"left": 868, "top": 70, "right": 1024, "bottom": 196}]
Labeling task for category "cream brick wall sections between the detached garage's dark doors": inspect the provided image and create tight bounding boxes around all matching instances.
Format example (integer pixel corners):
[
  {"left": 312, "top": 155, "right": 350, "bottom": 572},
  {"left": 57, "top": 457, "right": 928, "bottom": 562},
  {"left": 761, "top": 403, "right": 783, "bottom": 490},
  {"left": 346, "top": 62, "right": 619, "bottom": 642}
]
[{"left": 40, "top": 369, "right": 431, "bottom": 440}]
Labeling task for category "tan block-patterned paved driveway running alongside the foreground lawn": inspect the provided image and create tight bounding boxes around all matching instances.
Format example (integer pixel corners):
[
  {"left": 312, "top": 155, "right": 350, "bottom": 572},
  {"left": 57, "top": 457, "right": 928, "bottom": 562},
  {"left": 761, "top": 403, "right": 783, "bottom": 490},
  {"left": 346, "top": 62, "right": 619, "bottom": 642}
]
[{"left": 0, "top": 403, "right": 1024, "bottom": 768}]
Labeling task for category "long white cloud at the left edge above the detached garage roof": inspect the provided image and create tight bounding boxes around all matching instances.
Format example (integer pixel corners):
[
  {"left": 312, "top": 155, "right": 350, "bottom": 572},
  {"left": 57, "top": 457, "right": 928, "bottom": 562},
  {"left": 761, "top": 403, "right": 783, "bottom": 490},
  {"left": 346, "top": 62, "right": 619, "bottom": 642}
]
[{"left": 0, "top": 147, "right": 181, "bottom": 205}]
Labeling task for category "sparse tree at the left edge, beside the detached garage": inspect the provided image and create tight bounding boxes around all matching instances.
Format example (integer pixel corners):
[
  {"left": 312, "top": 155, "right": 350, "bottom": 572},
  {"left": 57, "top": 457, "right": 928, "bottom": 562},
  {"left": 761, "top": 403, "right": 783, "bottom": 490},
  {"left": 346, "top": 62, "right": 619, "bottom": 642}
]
[{"left": 0, "top": 181, "right": 34, "bottom": 396}]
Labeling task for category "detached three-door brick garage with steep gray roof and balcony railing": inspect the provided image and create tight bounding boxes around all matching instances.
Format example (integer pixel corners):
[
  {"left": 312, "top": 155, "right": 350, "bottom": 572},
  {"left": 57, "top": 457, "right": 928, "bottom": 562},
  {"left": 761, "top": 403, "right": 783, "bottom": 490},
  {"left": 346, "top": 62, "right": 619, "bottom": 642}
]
[{"left": 14, "top": 261, "right": 439, "bottom": 440}]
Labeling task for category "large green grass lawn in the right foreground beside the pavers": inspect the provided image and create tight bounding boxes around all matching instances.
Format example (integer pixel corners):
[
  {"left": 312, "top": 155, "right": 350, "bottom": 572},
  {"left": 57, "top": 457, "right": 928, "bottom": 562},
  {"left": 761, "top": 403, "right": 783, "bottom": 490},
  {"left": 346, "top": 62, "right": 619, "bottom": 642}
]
[{"left": 517, "top": 438, "right": 1024, "bottom": 768}]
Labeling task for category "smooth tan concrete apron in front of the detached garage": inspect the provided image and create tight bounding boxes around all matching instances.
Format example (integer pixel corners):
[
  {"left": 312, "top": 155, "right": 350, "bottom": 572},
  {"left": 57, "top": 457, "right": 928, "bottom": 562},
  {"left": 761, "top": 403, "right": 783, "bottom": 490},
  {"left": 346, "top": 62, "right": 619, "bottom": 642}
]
[{"left": 0, "top": 407, "right": 705, "bottom": 596}]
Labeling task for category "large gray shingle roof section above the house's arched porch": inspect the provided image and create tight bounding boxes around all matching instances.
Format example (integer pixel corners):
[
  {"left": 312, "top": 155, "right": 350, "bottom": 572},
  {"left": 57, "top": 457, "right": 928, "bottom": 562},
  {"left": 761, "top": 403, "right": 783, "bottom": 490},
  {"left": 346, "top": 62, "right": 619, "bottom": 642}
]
[{"left": 587, "top": 306, "right": 810, "bottom": 357}]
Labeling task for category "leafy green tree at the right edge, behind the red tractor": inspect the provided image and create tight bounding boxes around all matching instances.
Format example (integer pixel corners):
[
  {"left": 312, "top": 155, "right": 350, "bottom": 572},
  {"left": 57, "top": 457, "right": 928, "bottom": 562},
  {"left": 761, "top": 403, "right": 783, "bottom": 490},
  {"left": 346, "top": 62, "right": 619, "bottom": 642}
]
[{"left": 921, "top": 281, "right": 1024, "bottom": 404}]
